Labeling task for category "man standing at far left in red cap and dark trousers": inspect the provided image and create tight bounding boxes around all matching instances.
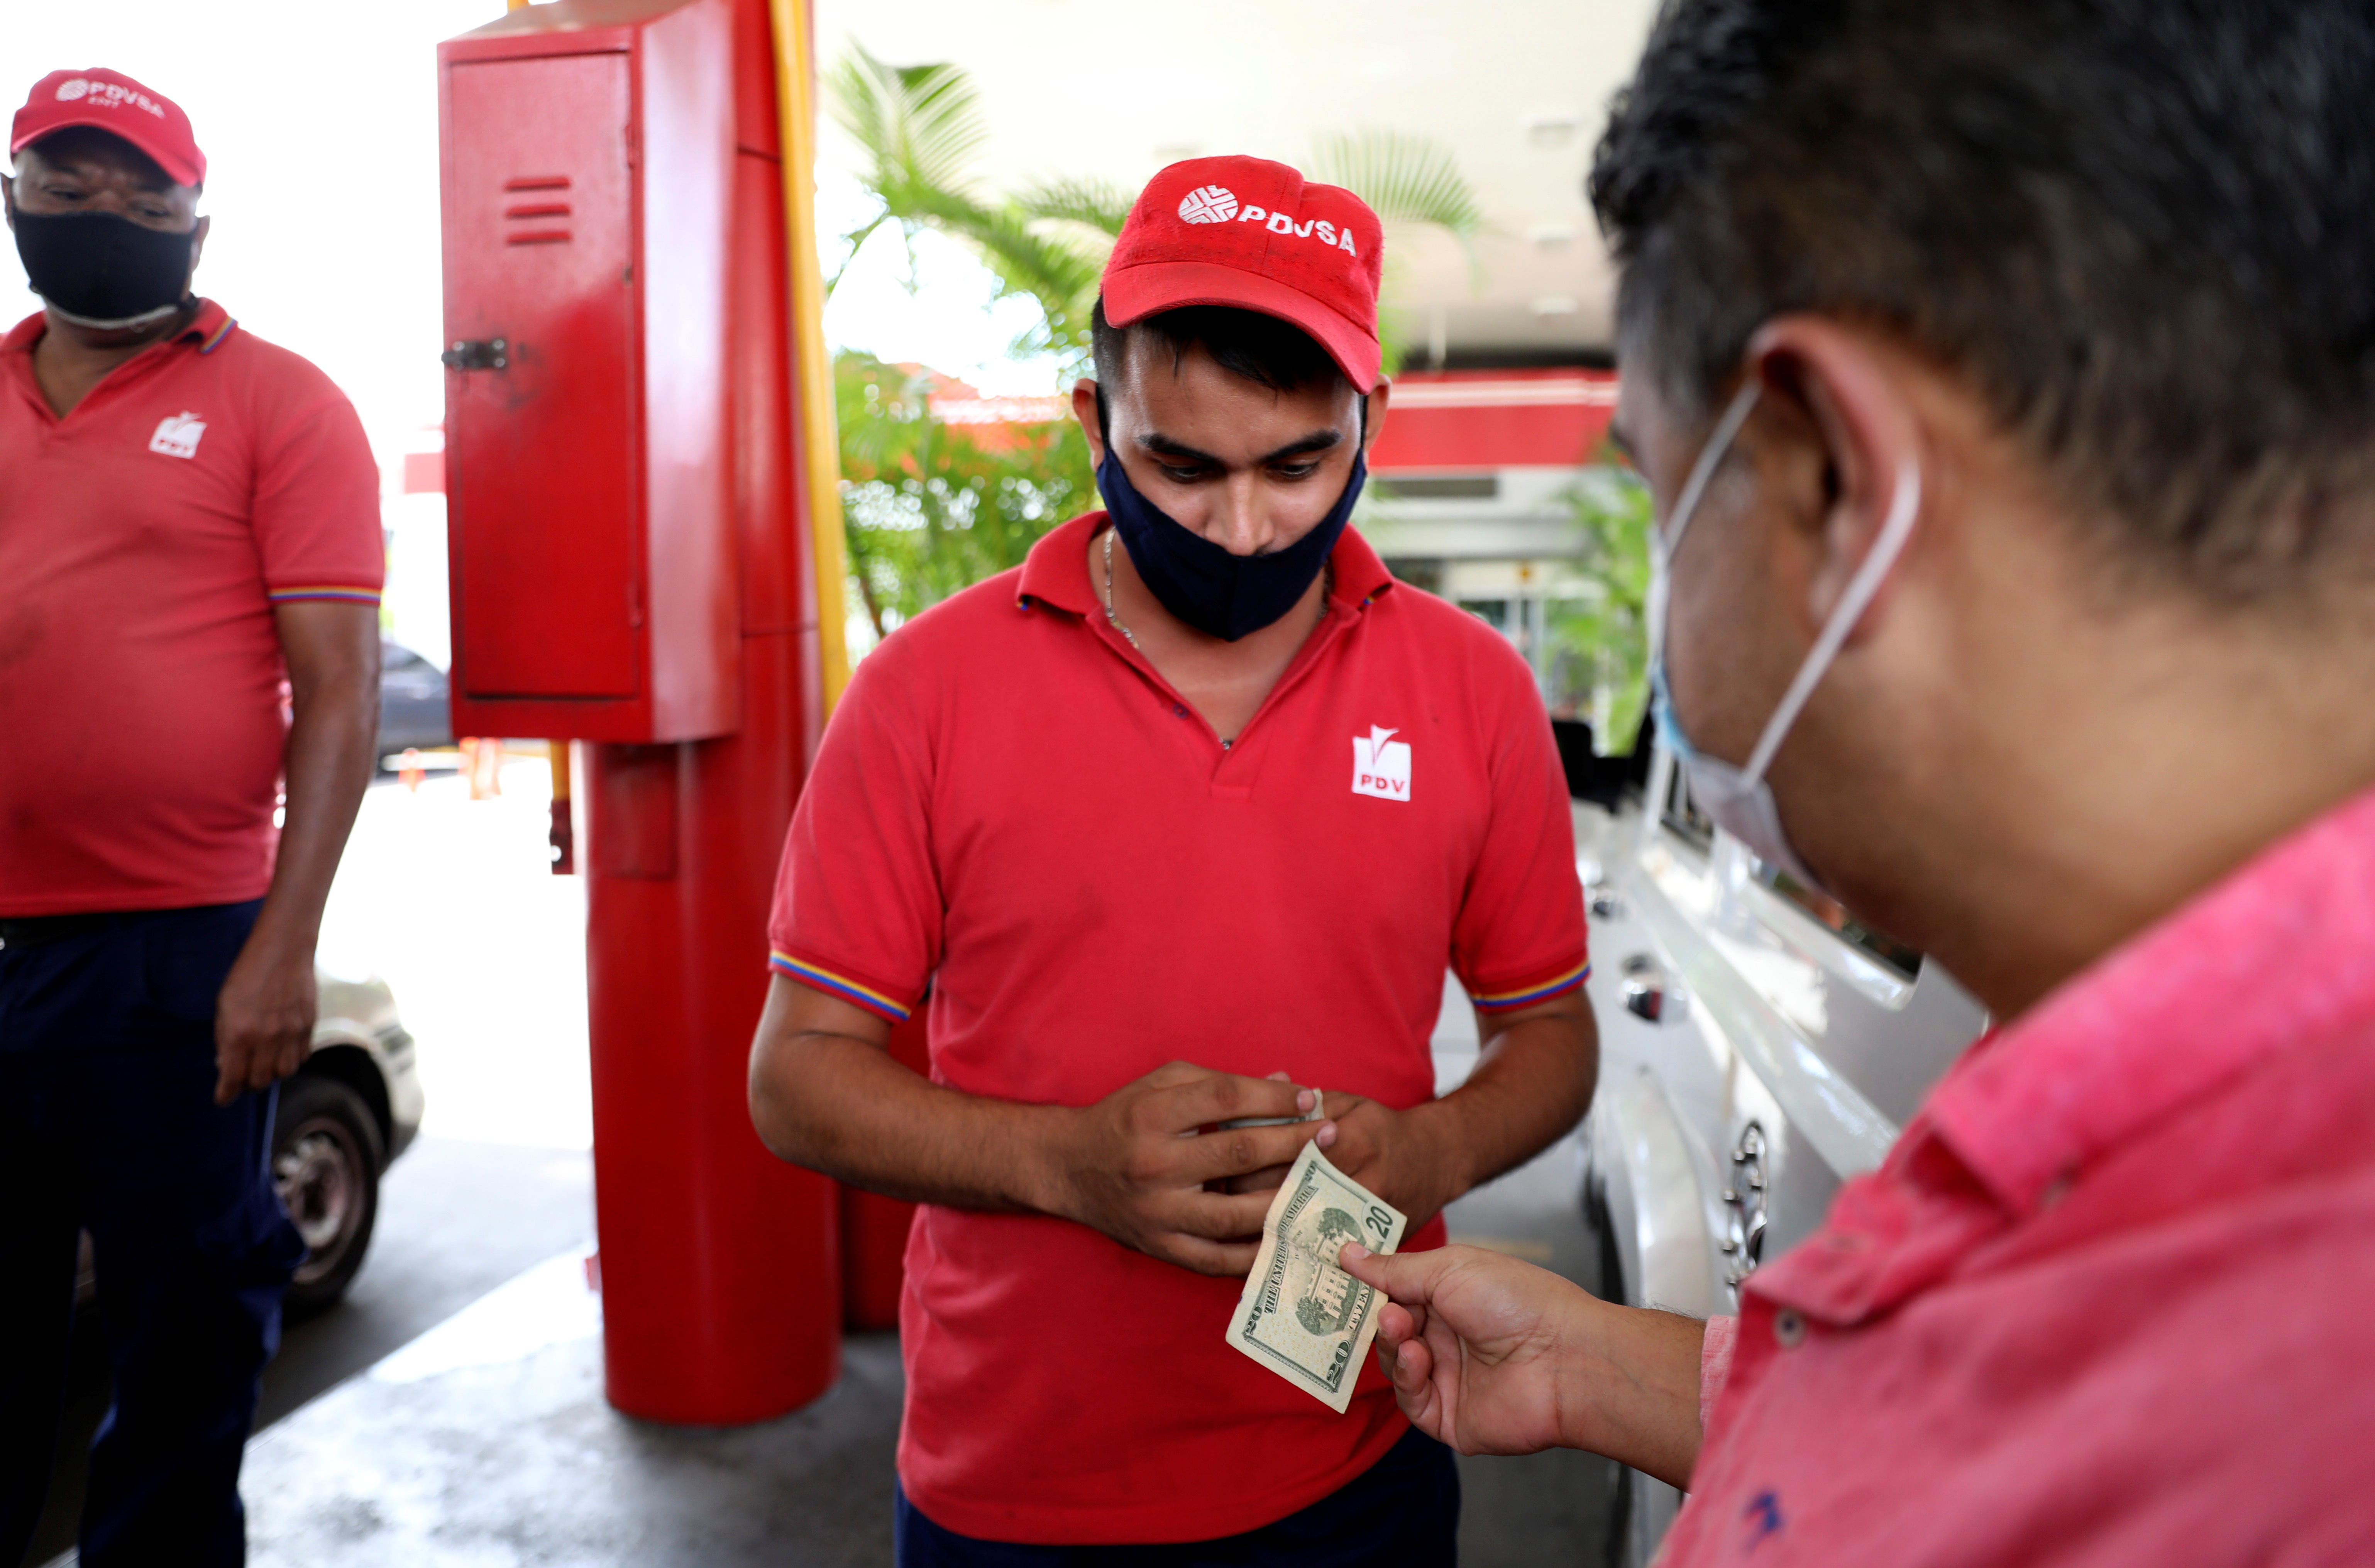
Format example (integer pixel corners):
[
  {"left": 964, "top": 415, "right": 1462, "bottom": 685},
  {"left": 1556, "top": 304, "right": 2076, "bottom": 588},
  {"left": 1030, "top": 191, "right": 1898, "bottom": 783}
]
[{"left": 0, "top": 71, "right": 383, "bottom": 1568}]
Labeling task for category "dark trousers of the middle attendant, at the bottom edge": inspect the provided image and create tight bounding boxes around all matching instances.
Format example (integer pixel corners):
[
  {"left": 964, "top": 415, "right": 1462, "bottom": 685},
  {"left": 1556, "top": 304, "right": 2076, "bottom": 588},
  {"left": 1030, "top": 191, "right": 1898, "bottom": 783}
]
[{"left": 890, "top": 1428, "right": 1461, "bottom": 1568}]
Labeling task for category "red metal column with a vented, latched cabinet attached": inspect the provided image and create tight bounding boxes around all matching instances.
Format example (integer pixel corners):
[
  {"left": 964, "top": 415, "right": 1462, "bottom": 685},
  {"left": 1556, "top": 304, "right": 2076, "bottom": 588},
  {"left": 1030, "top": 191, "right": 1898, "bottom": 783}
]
[{"left": 437, "top": 0, "right": 841, "bottom": 1426}]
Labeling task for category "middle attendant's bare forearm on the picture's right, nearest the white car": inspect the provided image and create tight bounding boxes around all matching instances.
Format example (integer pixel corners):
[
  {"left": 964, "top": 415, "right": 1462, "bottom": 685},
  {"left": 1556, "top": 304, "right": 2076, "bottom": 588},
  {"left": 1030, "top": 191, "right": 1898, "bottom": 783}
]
[{"left": 1413, "top": 998, "right": 1598, "bottom": 1202}]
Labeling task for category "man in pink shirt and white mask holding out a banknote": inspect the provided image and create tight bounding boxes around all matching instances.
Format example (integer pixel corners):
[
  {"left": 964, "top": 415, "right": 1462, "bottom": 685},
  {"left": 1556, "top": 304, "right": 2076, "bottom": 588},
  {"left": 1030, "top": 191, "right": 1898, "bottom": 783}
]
[{"left": 1347, "top": 0, "right": 2375, "bottom": 1568}]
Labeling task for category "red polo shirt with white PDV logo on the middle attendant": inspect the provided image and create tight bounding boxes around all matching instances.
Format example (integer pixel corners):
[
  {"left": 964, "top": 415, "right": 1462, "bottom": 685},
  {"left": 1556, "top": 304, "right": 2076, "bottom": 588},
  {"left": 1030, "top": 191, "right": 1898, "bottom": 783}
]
[{"left": 772, "top": 513, "right": 1584, "bottom": 1544}]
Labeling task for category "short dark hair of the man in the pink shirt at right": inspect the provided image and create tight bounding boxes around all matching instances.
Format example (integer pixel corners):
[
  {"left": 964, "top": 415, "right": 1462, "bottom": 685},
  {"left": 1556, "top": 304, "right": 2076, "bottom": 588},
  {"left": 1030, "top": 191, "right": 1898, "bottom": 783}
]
[{"left": 1589, "top": 0, "right": 2375, "bottom": 599}]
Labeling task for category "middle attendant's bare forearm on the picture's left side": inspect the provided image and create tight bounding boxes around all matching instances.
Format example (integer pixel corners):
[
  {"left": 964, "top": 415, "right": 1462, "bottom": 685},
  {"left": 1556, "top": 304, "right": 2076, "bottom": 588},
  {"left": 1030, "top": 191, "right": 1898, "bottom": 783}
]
[{"left": 753, "top": 1033, "right": 1073, "bottom": 1214}]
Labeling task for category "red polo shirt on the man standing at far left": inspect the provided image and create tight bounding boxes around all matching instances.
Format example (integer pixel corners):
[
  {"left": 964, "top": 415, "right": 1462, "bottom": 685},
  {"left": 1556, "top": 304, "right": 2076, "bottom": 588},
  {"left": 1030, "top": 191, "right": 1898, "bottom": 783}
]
[{"left": 0, "top": 302, "right": 385, "bottom": 915}]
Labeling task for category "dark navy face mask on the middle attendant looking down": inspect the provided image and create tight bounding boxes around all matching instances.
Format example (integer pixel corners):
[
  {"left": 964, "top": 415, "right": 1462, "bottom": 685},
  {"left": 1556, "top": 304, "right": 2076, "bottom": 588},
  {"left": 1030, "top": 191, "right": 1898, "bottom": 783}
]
[{"left": 1097, "top": 397, "right": 1368, "bottom": 642}]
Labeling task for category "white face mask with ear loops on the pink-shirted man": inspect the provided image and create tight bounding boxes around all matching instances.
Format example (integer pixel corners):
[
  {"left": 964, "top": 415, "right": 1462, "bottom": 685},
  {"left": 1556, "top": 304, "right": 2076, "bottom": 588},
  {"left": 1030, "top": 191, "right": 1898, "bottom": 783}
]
[{"left": 1648, "top": 380, "right": 1921, "bottom": 893}]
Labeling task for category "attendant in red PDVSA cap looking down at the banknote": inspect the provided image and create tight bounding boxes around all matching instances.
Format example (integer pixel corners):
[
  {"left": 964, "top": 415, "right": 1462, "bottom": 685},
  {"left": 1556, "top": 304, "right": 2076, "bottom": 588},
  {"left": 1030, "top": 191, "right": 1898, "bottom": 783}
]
[{"left": 750, "top": 157, "right": 1596, "bottom": 1568}]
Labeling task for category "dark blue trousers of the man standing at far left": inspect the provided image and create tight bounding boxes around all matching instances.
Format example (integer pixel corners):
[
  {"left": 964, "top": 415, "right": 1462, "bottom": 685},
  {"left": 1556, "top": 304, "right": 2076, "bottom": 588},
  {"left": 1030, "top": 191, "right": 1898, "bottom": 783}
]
[{"left": 0, "top": 903, "right": 304, "bottom": 1568}]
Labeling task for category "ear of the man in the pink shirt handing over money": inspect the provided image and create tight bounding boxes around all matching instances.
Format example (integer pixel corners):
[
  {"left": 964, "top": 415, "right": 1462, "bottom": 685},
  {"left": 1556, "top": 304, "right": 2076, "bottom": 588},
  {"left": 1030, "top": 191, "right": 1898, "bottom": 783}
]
[{"left": 1748, "top": 316, "right": 1924, "bottom": 644}]
